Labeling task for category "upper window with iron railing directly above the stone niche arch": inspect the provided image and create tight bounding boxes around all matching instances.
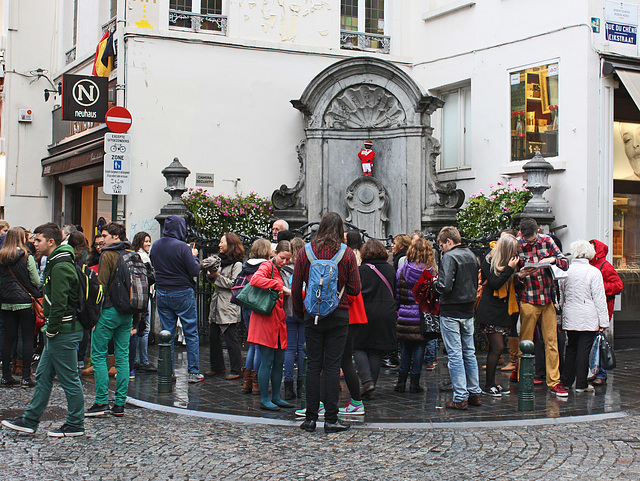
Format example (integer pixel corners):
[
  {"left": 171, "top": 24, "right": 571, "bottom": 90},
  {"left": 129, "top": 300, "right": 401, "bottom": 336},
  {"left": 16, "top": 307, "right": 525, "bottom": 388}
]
[{"left": 340, "top": 0, "right": 391, "bottom": 53}]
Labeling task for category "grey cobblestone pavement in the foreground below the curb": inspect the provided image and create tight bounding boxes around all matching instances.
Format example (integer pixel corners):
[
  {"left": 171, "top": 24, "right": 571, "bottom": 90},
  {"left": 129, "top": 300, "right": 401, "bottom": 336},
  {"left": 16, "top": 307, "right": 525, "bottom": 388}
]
[{"left": 0, "top": 384, "right": 640, "bottom": 480}]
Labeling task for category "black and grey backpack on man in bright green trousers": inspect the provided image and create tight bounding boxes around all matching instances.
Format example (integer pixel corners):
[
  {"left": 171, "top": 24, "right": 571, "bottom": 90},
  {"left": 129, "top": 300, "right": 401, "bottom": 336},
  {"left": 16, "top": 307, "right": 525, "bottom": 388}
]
[{"left": 109, "top": 249, "right": 149, "bottom": 314}]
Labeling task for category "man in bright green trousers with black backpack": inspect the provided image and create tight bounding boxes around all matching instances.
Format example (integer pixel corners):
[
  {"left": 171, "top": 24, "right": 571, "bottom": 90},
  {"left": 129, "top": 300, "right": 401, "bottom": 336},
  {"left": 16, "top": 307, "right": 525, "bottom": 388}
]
[{"left": 85, "top": 222, "right": 144, "bottom": 417}]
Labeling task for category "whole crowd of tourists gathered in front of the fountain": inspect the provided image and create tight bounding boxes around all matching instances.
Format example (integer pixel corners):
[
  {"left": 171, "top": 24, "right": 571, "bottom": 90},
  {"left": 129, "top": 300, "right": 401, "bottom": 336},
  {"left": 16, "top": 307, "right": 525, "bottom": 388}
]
[{"left": 0, "top": 212, "right": 622, "bottom": 437}]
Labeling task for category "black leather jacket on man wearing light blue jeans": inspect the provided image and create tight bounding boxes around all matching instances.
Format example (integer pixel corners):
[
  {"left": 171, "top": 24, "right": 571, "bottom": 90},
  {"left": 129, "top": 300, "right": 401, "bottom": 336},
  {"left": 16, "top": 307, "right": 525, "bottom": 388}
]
[{"left": 434, "top": 244, "right": 478, "bottom": 317}]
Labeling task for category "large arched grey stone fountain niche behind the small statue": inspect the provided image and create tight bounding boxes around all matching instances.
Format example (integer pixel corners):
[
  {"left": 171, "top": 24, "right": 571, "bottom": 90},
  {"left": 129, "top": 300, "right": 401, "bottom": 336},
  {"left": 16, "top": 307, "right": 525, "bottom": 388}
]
[{"left": 272, "top": 57, "right": 464, "bottom": 238}]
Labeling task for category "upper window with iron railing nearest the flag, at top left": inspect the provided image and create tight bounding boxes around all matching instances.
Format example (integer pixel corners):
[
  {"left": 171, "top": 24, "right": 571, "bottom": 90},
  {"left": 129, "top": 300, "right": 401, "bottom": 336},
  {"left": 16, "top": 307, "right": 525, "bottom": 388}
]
[{"left": 169, "top": 0, "right": 227, "bottom": 34}]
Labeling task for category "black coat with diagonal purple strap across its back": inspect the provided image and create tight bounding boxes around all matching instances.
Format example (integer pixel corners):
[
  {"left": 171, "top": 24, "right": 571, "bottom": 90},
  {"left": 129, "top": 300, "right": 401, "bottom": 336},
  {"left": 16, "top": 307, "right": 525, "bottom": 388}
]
[{"left": 353, "top": 259, "right": 397, "bottom": 351}]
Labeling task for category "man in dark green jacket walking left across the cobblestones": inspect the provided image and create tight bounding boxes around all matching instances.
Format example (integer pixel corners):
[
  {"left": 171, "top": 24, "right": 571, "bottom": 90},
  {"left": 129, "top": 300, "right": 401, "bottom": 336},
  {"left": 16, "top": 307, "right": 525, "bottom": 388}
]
[{"left": 2, "top": 222, "right": 84, "bottom": 438}]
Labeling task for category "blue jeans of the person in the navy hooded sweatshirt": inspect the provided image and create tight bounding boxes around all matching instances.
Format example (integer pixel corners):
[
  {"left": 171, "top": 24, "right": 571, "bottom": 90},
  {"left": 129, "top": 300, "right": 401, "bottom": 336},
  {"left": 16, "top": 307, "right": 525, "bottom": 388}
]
[{"left": 156, "top": 289, "right": 200, "bottom": 373}]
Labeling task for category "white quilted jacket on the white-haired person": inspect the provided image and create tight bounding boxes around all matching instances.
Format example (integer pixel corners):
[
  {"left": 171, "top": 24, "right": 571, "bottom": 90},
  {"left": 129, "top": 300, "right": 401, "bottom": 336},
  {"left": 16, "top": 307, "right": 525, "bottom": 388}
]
[{"left": 560, "top": 259, "right": 609, "bottom": 331}]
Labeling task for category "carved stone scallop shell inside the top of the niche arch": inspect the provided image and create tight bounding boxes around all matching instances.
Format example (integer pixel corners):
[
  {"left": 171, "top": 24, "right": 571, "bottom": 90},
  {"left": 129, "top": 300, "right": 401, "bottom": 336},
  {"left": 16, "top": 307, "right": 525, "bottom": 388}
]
[{"left": 324, "top": 85, "right": 406, "bottom": 129}]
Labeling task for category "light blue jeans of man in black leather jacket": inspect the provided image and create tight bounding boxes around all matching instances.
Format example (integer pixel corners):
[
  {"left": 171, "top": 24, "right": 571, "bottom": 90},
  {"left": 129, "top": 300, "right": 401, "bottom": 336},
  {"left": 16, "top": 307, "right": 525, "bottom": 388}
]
[{"left": 440, "top": 316, "right": 482, "bottom": 402}]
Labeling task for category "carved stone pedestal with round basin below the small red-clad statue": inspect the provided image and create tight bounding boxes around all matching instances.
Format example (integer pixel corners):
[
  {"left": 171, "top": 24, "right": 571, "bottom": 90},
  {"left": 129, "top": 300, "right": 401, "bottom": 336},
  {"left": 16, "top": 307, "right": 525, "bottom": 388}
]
[{"left": 345, "top": 176, "right": 389, "bottom": 239}]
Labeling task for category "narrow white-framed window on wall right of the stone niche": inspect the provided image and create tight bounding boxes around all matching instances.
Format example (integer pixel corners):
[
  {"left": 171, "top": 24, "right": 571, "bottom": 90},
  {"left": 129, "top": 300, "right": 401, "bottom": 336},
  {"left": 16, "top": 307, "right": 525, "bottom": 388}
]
[{"left": 440, "top": 85, "right": 471, "bottom": 170}]
